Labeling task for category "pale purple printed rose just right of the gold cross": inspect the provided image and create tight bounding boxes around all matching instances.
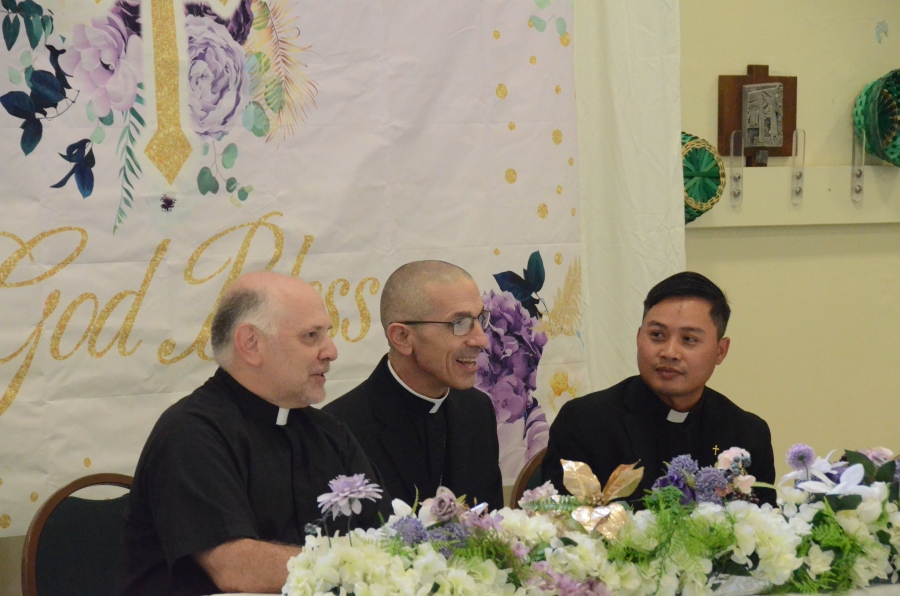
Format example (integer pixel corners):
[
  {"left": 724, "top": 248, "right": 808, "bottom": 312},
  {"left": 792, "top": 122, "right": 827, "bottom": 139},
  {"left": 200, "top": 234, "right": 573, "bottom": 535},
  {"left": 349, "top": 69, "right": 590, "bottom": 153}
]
[{"left": 185, "top": 16, "right": 249, "bottom": 140}]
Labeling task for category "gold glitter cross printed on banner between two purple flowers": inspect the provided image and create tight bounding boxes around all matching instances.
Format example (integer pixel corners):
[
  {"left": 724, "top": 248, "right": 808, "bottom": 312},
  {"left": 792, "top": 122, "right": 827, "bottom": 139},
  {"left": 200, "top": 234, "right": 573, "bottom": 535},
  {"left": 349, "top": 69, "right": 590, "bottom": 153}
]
[{"left": 144, "top": 0, "right": 228, "bottom": 184}]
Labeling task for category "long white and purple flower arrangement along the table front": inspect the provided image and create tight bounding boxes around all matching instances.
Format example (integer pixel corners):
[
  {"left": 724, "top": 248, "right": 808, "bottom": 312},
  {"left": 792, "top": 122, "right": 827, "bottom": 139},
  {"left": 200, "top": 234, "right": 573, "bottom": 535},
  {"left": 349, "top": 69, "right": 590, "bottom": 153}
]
[{"left": 284, "top": 445, "right": 900, "bottom": 596}]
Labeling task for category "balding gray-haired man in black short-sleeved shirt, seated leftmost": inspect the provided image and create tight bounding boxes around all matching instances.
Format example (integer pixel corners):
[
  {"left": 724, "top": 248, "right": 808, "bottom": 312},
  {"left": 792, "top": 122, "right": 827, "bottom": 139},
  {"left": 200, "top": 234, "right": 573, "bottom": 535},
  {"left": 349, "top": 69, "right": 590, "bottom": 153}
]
[{"left": 120, "top": 271, "right": 390, "bottom": 596}]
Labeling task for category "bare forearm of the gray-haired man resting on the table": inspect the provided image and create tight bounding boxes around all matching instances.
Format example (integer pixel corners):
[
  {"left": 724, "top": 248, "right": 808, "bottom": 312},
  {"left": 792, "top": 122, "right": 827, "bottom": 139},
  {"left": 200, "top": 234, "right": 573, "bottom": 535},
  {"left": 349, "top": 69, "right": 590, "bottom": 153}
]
[{"left": 194, "top": 538, "right": 301, "bottom": 594}]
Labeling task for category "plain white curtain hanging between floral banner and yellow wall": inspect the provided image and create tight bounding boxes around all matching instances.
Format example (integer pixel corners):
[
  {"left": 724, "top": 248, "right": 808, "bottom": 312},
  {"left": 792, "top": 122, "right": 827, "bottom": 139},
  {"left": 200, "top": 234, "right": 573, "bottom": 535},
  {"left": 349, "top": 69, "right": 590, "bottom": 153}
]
[{"left": 575, "top": 0, "right": 685, "bottom": 390}]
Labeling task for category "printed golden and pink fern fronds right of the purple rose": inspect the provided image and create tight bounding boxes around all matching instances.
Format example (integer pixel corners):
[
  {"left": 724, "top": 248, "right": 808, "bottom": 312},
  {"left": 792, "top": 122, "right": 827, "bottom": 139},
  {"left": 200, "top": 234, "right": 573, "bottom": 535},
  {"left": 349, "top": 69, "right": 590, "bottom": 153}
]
[{"left": 245, "top": 0, "right": 318, "bottom": 141}]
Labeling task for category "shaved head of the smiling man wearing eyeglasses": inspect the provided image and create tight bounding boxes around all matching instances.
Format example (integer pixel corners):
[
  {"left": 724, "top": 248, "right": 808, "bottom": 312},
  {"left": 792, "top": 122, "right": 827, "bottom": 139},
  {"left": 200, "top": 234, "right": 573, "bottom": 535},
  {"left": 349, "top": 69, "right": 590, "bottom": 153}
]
[{"left": 381, "top": 261, "right": 487, "bottom": 398}]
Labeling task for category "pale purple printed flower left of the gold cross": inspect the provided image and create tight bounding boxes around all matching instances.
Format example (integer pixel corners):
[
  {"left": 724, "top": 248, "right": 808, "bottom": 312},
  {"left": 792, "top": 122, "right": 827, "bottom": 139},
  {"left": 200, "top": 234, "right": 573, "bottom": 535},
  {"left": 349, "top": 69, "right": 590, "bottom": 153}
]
[{"left": 59, "top": 14, "right": 143, "bottom": 117}]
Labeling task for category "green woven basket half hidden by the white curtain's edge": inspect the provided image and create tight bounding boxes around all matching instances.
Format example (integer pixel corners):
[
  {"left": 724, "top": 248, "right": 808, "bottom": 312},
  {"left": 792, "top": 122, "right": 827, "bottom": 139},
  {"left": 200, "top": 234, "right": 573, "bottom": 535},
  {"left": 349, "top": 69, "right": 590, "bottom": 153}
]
[{"left": 681, "top": 132, "right": 725, "bottom": 224}]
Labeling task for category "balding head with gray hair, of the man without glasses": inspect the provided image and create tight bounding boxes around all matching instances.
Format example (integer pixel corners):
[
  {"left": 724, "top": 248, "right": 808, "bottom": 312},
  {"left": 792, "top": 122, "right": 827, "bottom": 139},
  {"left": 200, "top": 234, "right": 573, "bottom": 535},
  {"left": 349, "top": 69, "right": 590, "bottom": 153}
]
[{"left": 211, "top": 271, "right": 337, "bottom": 408}]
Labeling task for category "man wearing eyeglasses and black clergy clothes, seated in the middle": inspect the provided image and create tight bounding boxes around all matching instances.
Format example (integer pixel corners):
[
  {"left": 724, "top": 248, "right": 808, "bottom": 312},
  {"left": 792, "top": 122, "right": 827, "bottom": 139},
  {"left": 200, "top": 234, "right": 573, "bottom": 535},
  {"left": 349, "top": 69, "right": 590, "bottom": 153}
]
[{"left": 324, "top": 261, "right": 503, "bottom": 509}]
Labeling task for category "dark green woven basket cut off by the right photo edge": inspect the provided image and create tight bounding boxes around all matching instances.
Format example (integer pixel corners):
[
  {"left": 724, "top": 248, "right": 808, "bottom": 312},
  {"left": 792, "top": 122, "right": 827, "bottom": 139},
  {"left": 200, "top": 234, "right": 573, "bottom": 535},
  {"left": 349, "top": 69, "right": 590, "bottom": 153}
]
[{"left": 853, "top": 70, "right": 900, "bottom": 166}]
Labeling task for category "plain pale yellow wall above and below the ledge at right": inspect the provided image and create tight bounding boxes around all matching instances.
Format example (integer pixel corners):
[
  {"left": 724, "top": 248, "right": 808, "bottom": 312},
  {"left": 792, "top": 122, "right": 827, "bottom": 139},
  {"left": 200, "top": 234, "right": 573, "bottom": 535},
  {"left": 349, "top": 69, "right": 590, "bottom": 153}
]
[{"left": 681, "top": 0, "right": 900, "bottom": 472}]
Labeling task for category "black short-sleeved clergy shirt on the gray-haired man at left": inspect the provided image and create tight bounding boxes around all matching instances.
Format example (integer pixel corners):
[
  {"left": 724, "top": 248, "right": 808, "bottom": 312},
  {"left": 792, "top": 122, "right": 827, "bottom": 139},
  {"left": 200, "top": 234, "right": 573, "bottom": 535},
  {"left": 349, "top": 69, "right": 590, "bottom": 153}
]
[{"left": 121, "top": 369, "right": 390, "bottom": 596}]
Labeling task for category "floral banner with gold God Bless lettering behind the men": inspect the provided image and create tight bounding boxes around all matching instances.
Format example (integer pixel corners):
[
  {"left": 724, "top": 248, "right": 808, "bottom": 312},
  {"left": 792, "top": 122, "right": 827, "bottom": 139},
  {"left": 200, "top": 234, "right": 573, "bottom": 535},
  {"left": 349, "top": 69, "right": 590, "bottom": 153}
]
[{"left": 0, "top": 0, "right": 586, "bottom": 536}]
